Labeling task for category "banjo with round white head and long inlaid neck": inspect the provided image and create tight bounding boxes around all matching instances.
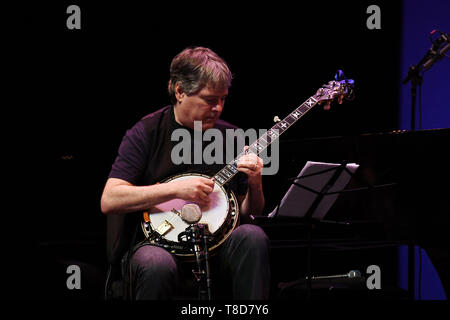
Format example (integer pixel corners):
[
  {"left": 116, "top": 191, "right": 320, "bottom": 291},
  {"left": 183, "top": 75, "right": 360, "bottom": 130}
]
[{"left": 141, "top": 70, "right": 353, "bottom": 258}]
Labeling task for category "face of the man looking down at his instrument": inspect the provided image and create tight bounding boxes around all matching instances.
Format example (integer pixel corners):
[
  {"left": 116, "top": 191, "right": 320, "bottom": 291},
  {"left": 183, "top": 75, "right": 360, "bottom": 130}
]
[{"left": 176, "top": 87, "right": 228, "bottom": 130}]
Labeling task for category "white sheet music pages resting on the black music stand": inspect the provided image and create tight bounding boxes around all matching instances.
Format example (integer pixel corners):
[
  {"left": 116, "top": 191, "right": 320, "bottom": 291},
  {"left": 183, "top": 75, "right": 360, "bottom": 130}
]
[{"left": 269, "top": 161, "right": 359, "bottom": 220}]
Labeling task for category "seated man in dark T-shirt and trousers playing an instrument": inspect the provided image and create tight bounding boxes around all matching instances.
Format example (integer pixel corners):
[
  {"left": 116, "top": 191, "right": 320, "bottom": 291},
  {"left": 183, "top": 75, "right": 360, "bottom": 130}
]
[{"left": 101, "top": 47, "right": 270, "bottom": 299}]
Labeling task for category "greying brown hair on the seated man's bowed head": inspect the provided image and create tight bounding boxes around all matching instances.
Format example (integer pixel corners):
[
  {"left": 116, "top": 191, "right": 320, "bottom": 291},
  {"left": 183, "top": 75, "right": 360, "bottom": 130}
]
[{"left": 168, "top": 47, "right": 233, "bottom": 104}]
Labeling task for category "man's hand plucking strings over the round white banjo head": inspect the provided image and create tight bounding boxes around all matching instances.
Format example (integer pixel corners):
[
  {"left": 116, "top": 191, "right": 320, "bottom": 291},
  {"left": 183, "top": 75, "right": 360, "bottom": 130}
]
[{"left": 169, "top": 177, "right": 214, "bottom": 207}]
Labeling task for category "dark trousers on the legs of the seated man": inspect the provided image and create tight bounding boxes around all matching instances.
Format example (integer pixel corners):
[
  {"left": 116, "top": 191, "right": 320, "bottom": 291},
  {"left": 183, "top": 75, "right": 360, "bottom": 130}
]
[{"left": 125, "top": 224, "right": 270, "bottom": 299}]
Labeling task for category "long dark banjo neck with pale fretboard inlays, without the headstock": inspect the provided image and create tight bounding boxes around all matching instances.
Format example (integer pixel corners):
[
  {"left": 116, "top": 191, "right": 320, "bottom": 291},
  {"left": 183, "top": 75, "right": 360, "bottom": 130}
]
[{"left": 214, "top": 94, "right": 319, "bottom": 186}]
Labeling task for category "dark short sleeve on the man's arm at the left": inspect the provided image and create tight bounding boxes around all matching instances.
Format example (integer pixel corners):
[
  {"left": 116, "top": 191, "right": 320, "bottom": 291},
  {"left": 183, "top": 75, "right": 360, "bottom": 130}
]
[{"left": 108, "top": 121, "right": 149, "bottom": 185}]
